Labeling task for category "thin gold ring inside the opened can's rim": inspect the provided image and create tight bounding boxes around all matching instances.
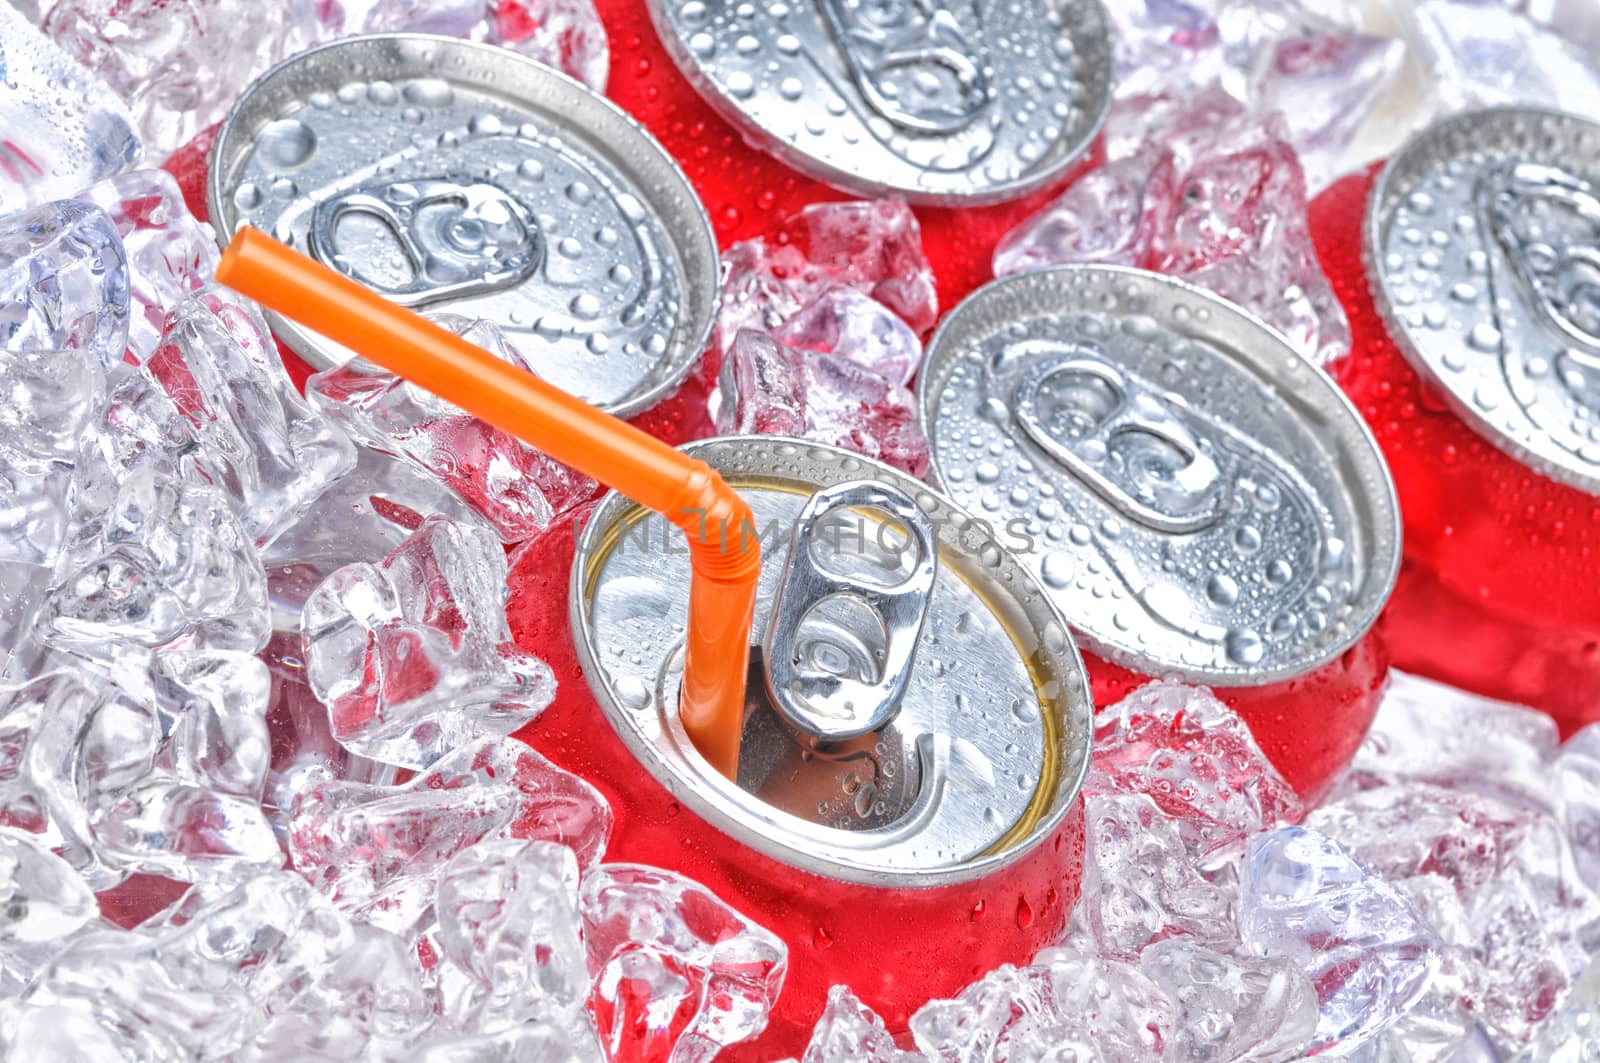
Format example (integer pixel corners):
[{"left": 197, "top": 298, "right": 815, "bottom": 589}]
[{"left": 582, "top": 474, "right": 1061, "bottom": 860}]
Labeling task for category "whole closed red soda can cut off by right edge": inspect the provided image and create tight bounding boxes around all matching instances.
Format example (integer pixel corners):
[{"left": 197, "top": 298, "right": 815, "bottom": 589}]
[{"left": 1310, "top": 109, "right": 1600, "bottom": 732}]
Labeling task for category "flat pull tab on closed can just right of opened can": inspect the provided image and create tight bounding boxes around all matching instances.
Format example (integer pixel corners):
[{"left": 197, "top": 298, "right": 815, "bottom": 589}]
[{"left": 1013, "top": 354, "right": 1227, "bottom": 533}]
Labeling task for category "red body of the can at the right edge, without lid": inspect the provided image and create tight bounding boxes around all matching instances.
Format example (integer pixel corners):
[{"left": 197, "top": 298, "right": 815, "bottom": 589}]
[{"left": 1310, "top": 170, "right": 1600, "bottom": 732}]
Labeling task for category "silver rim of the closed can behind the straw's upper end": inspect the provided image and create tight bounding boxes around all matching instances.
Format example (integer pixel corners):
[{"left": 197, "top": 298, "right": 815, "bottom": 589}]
[{"left": 206, "top": 32, "right": 722, "bottom": 418}]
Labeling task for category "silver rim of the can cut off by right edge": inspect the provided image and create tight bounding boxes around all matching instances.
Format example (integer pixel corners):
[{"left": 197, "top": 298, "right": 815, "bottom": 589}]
[{"left": 1362, "top": 106, "right": 1600, "bottom": 495}]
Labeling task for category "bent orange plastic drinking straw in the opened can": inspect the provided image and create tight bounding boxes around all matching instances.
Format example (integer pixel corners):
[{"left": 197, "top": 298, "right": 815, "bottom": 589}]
[{"left": 216, "top": 227, "right": 762, "bottom": 778}]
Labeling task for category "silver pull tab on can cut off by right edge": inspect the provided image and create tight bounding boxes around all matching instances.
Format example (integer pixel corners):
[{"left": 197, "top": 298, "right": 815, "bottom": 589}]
[{"left": 1478, "top": 162, "right": 1600, "bottom": 352}]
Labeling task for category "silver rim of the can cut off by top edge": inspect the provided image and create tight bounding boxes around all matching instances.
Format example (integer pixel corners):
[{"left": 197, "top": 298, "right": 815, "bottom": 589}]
[{"left": 645, "top": 0, "right": 1115, "bottom": 207}]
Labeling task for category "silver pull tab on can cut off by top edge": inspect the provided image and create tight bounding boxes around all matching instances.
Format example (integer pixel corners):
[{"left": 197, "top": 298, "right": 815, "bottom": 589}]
[{"left": 819, "top": 0, "right": 990, "bottom": 134}]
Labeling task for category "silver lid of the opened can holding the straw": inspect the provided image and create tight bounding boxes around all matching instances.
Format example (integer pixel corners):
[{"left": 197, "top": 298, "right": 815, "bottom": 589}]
[{"left": 571, "top": 435, "right": 1093, "bottom": 885}]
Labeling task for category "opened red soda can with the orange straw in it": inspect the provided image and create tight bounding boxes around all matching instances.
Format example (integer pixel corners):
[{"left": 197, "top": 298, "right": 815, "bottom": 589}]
[{"left": 556, "top": 435, "right": 1093, "bottom": 1060}]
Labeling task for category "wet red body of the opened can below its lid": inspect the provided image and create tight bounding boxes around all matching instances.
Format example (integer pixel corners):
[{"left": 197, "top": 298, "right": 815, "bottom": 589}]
[{"left": 509, "top": 505, "right": 1083, "bottom": 1060}]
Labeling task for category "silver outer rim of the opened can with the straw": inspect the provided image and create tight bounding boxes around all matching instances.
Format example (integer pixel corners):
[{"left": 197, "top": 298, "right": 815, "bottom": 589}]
[{"left": 568, "top": 435, "right": 1094, "bottom": 889}]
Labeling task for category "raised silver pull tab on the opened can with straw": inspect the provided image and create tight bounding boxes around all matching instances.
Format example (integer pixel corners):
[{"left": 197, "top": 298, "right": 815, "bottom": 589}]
[{"left": 762, "top": 480, "right": 939, "bottom": 741}]
